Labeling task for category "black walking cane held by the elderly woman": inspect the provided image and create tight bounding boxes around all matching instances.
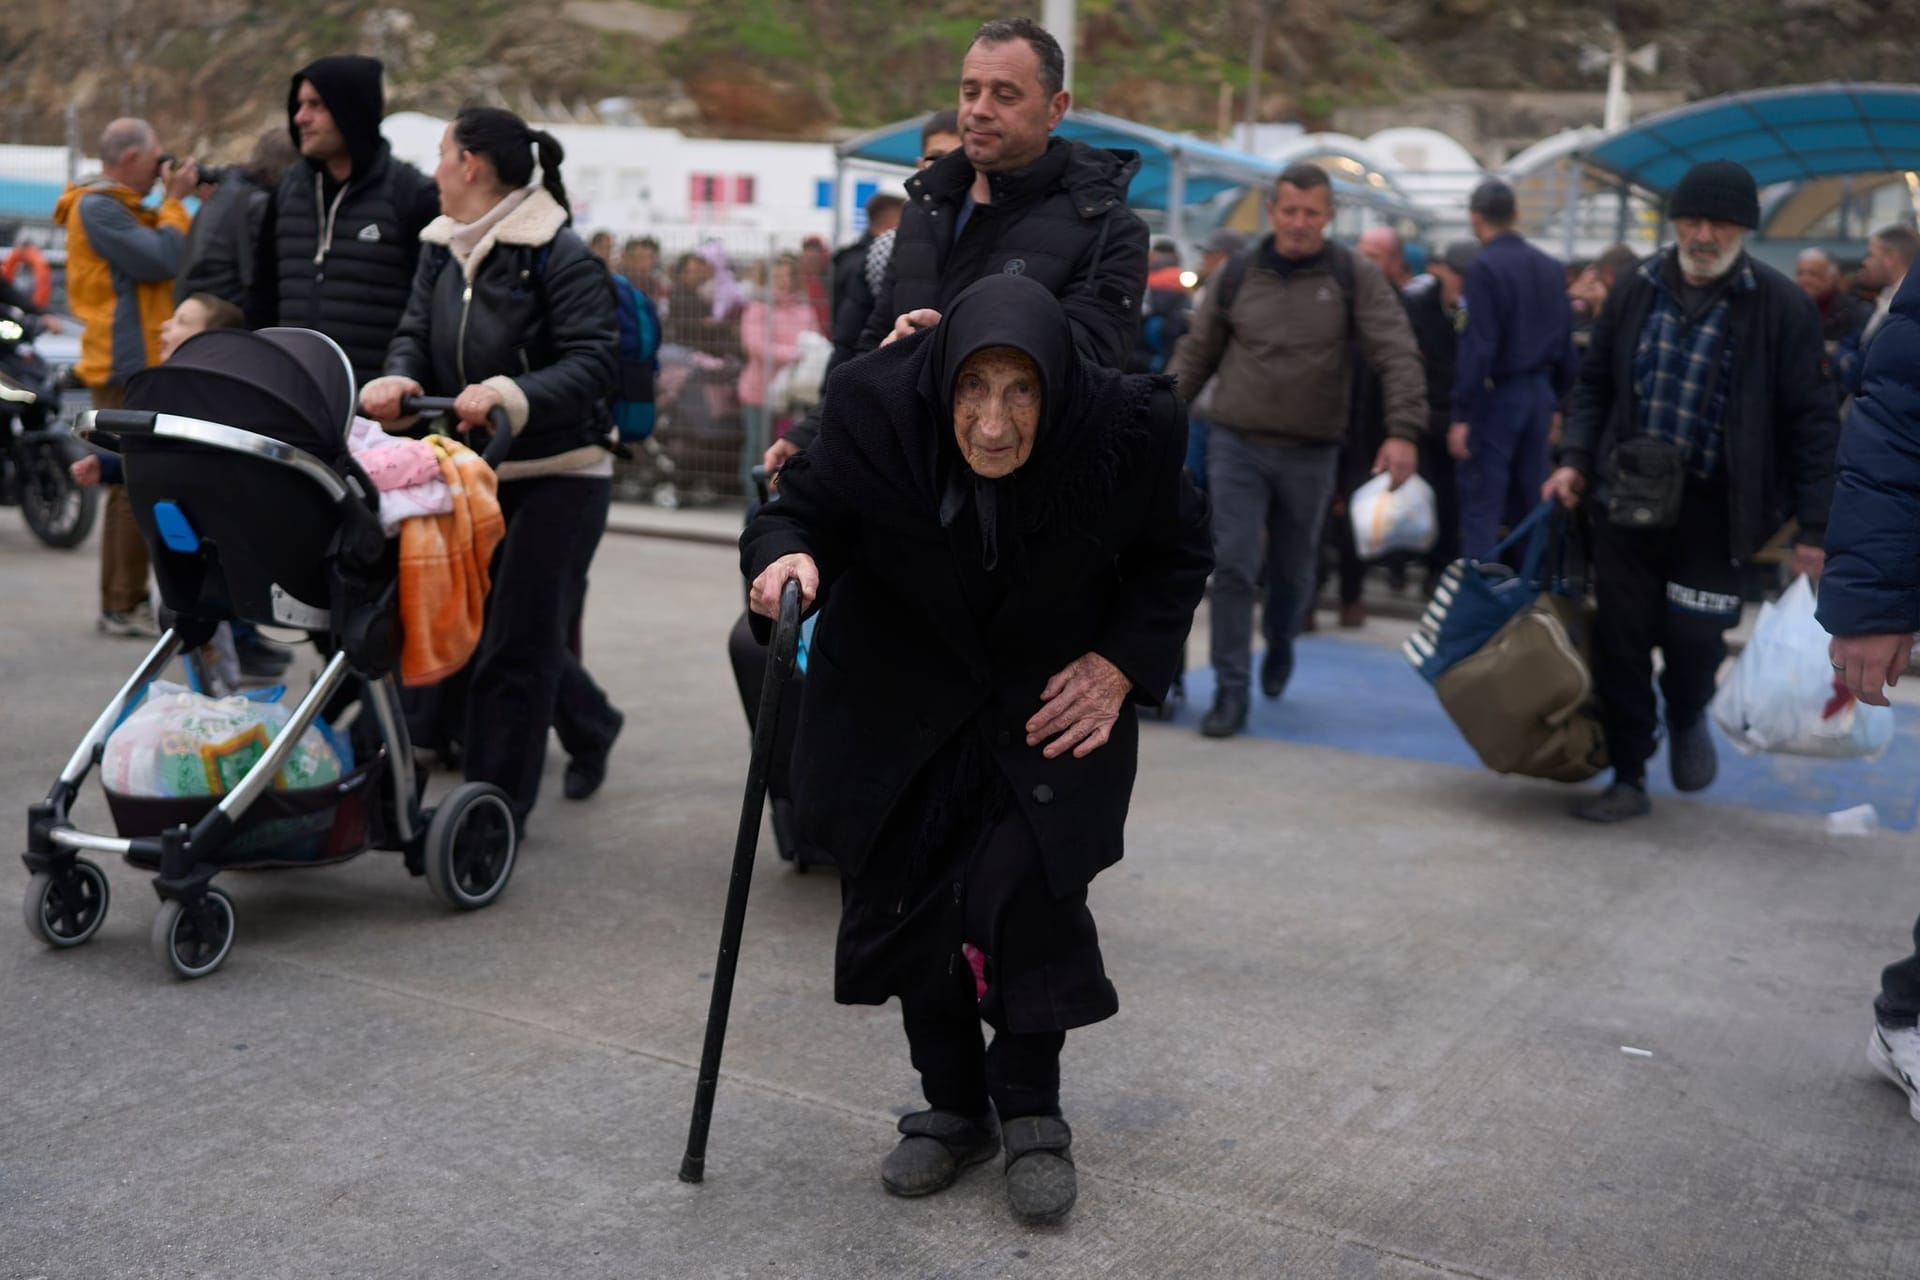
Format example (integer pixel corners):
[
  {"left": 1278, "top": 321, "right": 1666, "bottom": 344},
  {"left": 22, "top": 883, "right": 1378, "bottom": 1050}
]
[{"left": 680, "top": 578, "right": 801, "bottom": 1182}]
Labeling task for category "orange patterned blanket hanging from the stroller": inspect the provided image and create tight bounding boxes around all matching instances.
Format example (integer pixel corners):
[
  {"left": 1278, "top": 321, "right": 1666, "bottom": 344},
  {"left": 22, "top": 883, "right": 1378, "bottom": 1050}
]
[{"left": 399, "top": 436, "right": 507, "bottom": 685}]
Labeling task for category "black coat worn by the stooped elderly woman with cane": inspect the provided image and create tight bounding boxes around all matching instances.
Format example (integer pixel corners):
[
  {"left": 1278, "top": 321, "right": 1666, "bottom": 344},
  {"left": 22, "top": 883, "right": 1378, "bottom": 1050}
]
[{"left": 741, "top": 314, "right": 1213, "bottom": 894}]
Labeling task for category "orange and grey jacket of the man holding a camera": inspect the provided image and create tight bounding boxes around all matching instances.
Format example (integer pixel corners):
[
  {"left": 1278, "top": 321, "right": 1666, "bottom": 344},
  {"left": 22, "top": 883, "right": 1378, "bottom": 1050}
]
[{"left": 54, "top": 178, "right": 192, "bottom": 388}]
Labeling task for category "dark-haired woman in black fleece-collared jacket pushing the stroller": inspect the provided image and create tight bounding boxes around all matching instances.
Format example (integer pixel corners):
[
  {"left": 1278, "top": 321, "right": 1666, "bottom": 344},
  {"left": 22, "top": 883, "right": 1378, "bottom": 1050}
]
[{"left": 361, "top": 107, "right": 622, "bottom": 827}]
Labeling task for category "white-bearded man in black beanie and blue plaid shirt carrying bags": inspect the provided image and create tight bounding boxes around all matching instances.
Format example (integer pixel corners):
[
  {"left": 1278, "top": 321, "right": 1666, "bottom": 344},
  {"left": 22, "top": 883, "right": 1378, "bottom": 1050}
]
[{"left": 1542, "top": 159, "right": 1839, "bottom": 821}]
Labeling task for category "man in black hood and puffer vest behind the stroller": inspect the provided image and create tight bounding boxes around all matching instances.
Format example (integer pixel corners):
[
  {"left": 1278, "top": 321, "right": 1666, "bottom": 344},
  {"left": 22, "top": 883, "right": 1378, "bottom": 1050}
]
[{"left": 248, "top": 56, "right": 440, "bottom": 384}]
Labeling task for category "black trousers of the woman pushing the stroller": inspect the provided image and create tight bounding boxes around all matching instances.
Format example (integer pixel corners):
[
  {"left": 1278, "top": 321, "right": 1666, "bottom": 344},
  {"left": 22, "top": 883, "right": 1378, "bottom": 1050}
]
[{"left": 465, "top": 476, "right": 612, "bottom": 821}]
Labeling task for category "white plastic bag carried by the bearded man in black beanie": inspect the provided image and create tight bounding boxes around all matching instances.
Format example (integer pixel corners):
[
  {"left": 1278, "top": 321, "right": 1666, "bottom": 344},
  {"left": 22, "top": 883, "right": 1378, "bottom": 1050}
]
[{"left": 1713, "top": 578, "right": 1893, "bottom": 760}]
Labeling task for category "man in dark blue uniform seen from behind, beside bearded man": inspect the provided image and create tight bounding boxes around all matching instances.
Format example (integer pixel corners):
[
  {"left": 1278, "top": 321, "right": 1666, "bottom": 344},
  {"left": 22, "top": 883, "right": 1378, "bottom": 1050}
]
[{"left": 1448, "top": 178, "right": 1578, "bottom": 560}]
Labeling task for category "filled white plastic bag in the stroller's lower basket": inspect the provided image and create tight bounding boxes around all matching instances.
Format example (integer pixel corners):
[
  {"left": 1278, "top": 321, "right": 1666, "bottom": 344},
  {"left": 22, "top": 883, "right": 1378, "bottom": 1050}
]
[{"left": 100, "top": 683, "right": 340, "bottom": 798}]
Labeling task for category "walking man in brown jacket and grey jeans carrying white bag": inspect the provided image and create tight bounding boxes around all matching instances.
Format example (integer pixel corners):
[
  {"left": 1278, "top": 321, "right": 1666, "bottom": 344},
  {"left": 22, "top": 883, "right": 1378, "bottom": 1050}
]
[{"left": 1169, "top": 163, "right": 1427, "bottom": 737}]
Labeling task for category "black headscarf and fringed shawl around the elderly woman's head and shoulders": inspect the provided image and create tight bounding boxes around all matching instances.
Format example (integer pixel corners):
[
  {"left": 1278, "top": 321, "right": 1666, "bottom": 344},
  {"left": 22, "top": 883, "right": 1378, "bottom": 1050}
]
[{"left": 783, "top": 274, "right": 1173, "bottom": 575}]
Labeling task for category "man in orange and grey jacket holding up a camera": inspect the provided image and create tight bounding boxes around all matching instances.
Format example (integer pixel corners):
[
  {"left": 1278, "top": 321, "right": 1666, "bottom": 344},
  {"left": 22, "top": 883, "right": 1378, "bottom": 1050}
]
[{"left": 54, "top": 119, "right": 198, "bottom": 635}]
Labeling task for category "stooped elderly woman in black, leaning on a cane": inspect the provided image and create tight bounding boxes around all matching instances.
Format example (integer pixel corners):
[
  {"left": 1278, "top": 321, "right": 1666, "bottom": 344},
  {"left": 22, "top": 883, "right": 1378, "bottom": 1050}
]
[{"left": 741, "top": 276, "right": 1212, "bottom": 1222}]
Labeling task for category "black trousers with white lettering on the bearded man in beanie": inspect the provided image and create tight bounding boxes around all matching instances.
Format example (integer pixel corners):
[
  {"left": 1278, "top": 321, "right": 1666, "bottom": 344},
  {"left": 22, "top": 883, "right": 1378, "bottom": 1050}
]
[{"left": 1594, "top": 482, "right": 1740, "bottom": 783}]
